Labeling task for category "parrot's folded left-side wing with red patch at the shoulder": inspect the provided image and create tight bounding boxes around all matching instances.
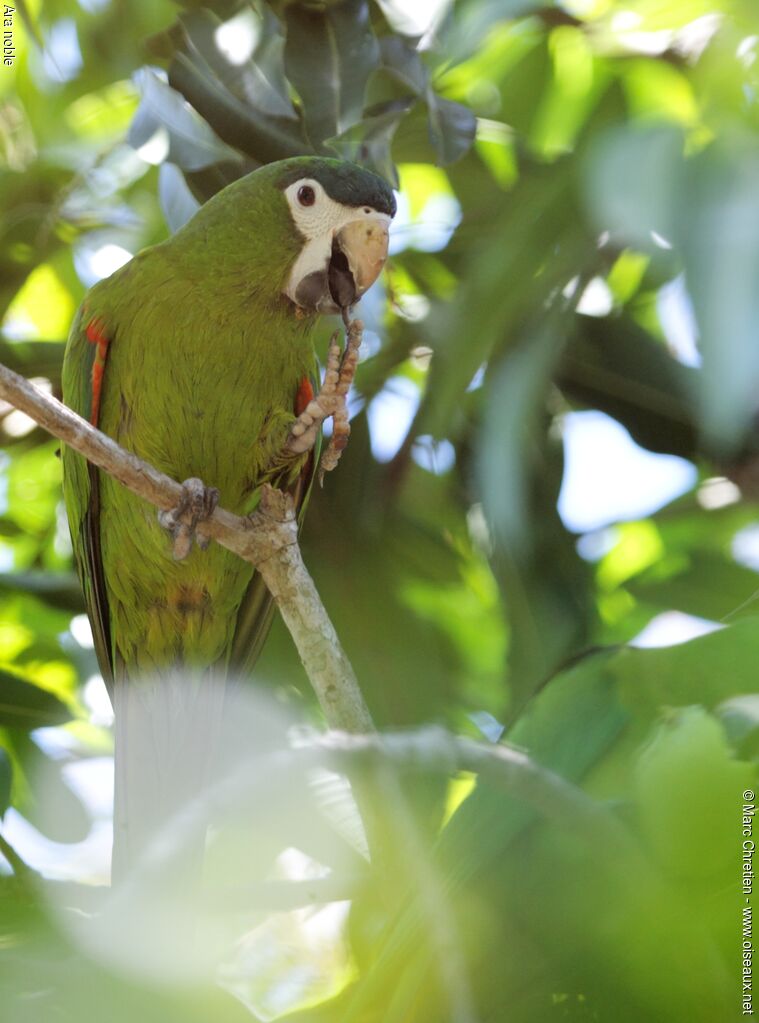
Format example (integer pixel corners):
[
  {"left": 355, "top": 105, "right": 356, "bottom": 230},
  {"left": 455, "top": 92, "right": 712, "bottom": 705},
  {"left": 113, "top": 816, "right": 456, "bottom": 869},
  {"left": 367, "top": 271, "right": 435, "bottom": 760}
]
[{"left": 61, "top": 307, "right": 114, "bottom": 696}]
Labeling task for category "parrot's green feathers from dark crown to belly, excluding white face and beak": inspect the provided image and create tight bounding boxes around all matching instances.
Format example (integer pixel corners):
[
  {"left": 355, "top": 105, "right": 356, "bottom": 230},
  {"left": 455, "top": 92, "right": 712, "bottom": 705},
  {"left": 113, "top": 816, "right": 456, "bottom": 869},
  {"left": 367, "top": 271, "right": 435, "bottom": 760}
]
[{"left": 62, "top": 158, "right": 392, "bottom": 875}]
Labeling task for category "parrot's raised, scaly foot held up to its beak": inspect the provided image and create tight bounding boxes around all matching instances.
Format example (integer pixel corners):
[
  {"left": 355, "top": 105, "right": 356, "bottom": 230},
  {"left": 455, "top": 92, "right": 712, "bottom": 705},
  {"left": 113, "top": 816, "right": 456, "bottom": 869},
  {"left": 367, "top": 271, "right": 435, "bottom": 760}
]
[{"left": 287, "top": 320, "right": 363, "bottom": 483}]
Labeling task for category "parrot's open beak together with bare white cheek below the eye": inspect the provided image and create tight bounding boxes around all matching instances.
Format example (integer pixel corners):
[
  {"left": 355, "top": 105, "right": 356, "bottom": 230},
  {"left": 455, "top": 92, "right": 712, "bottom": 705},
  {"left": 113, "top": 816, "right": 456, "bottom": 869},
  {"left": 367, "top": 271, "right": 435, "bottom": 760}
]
[{"left": 285, "top": 211, "right": 390, "bottom": 313}]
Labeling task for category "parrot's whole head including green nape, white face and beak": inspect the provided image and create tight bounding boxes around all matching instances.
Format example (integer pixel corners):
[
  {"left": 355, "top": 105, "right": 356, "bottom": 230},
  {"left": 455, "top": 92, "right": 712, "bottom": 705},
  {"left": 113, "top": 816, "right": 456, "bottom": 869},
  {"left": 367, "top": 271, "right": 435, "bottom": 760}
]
[{"left": 184, "top": 157, "right": 396, "bottom": 313}]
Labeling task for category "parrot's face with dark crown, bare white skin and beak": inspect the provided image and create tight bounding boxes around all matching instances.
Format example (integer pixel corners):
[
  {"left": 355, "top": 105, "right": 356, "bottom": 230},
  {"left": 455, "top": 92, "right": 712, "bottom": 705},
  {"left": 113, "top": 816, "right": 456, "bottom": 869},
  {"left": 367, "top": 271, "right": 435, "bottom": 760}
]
[{"left": 277, "top": 158, "right": 396, "bottom": 313}]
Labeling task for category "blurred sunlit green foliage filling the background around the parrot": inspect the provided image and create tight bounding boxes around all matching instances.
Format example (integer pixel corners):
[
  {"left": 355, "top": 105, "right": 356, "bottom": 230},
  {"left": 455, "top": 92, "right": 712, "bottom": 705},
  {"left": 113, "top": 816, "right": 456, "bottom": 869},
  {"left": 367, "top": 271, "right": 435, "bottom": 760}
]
[{"left": 0, "top": 0, "right": 759, "bottom": 1023}]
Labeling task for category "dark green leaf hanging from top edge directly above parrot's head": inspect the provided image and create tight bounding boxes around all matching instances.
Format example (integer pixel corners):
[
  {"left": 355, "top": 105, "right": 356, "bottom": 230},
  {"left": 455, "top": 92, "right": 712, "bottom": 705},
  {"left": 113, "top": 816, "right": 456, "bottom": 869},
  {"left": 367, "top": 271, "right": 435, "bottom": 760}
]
[{"left": 284, "top": 0, "right": 380, "bottom": 146}]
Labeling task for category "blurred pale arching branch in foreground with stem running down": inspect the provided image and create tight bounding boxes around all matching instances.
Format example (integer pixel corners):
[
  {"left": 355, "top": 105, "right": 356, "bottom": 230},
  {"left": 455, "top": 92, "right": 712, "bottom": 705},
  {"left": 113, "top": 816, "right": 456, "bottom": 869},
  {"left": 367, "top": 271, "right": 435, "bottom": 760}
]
[{"left": 93, "top": 727, "right": 645, "bottom": 1023}]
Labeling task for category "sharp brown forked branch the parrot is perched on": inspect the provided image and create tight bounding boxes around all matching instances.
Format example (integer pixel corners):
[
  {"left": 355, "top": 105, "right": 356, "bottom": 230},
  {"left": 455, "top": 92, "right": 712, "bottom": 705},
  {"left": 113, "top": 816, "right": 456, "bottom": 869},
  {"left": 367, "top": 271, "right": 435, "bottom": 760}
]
[{"left": 0, "top": 365, "right": 373, "bottom": 732}]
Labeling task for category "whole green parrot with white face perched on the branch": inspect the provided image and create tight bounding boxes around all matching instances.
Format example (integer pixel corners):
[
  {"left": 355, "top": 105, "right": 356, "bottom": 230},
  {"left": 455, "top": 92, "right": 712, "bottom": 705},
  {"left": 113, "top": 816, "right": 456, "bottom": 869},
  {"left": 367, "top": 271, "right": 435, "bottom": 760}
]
[{"left": 62, "top": 157, "right": 396, "bottom": 875}]
